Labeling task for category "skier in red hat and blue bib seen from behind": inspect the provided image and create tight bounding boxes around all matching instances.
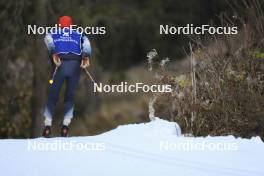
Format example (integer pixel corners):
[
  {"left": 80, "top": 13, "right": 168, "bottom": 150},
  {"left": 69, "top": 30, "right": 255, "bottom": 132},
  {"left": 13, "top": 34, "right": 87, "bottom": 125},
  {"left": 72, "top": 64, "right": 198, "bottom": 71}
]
[{"left": 42, "top": 16, "right": 91, "bottom": 137}]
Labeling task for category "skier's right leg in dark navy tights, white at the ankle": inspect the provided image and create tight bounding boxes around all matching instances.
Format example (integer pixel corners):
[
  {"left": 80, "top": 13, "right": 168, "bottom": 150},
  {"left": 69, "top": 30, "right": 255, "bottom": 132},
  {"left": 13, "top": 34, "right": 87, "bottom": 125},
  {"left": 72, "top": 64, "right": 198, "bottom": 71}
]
[{"left": 63, "top": 60, "right": 80, "bottom": 126}]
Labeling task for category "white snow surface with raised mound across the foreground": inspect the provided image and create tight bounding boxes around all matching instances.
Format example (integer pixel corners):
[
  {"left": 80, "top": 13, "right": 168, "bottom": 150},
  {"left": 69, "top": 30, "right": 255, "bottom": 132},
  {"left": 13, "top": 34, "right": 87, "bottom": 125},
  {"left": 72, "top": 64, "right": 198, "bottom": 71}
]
[{"left": 0, "top": 118, "right": 264, "bottom": 176}]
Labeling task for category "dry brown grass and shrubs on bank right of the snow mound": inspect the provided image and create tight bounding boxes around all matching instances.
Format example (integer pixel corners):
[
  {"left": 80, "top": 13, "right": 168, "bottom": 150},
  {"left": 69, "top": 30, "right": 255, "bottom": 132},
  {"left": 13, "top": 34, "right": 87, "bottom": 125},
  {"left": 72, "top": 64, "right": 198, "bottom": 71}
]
[{"left": 150, "top": 0, "right": 264, "bottom": 140}]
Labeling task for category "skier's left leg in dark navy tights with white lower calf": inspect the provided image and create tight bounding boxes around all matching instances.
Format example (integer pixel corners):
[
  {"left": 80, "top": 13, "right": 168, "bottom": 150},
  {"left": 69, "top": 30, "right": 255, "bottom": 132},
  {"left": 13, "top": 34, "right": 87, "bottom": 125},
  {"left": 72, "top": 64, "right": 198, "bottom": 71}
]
[{"left": 44, "top": 66, "right": 65, "bottom": 126}]
